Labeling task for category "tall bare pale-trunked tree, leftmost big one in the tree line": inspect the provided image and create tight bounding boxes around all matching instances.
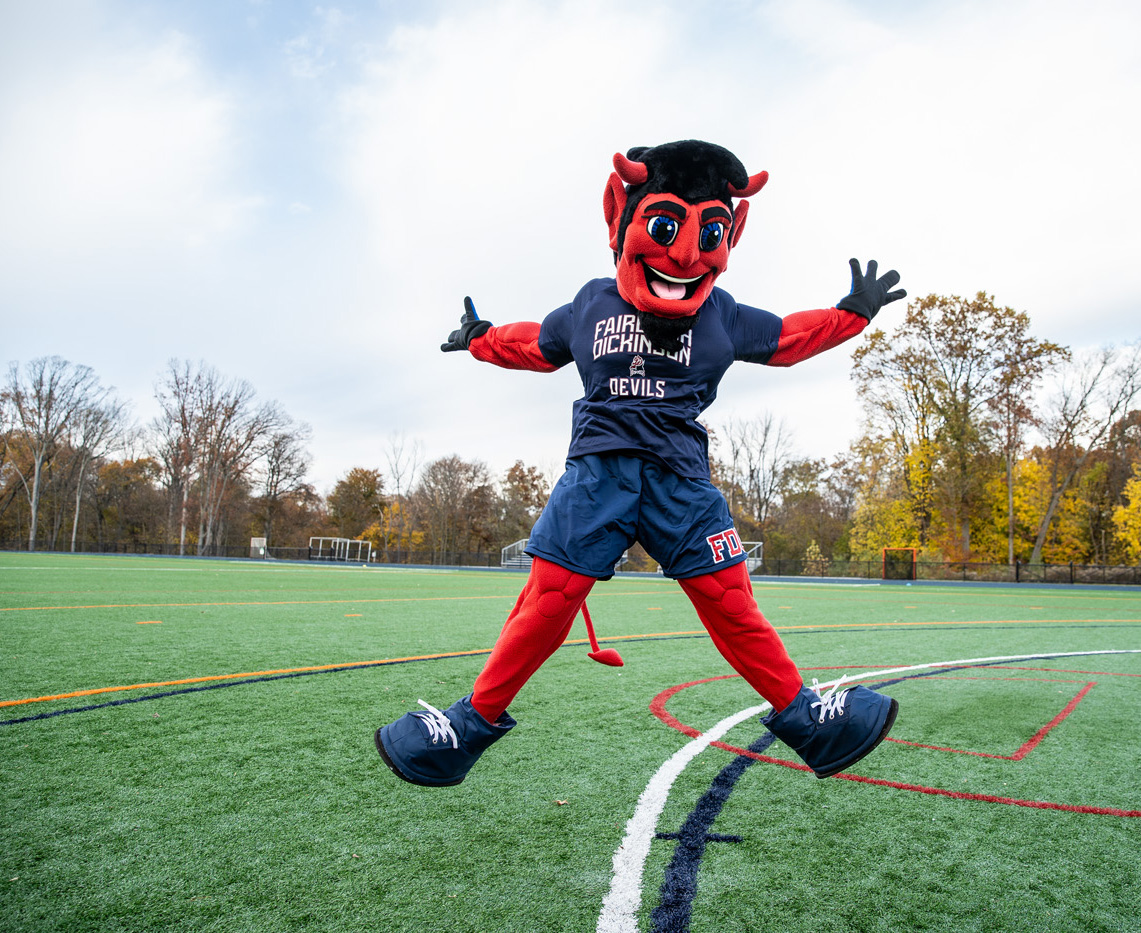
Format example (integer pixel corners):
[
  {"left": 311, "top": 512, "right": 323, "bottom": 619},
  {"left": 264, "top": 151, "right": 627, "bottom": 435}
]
[{"left": 3, "top": 356, "right": 107, "bottom": 551}]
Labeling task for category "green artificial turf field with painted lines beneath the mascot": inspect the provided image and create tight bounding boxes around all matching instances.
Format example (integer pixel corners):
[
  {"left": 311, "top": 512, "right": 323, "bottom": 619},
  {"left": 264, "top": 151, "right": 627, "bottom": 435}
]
[{"left": 0, "top": 553, "right": 1141, "bottom": 933}]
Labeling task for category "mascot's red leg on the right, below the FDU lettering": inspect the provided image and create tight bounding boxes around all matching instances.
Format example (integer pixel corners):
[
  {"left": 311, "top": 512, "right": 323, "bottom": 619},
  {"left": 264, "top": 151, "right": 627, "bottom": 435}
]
[{"left": 678, "top": 563, "right": 804, "bottom": 712}]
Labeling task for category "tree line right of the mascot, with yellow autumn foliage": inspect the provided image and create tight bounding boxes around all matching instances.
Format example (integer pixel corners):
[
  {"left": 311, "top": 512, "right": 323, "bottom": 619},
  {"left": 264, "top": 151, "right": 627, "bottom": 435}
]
[{"left": 714, "top": 292, "right": 1141, "bottom": 565}]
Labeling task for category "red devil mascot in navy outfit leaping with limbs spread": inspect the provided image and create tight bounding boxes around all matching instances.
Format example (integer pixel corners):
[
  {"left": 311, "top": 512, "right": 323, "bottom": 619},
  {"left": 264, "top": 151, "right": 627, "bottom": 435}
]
[{"left": 375, "top": 140, "right": 905, "bottom": 786}]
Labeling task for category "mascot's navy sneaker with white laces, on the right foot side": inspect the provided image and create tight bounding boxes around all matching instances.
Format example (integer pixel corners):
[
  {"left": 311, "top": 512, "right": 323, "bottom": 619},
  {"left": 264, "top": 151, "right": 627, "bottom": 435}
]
[{"left": 761, "top": 678, "right": 899, "bottom": 778}]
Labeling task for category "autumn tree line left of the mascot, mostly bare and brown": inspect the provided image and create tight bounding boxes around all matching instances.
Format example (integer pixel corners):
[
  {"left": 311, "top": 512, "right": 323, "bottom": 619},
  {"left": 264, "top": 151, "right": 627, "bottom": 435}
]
[{"left": 0, "top": 357, "right": 549, "bottom": 562}]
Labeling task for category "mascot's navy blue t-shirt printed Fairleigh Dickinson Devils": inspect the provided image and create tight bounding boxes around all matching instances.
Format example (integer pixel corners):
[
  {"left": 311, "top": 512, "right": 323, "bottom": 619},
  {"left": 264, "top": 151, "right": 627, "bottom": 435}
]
[{"left": 539, "top": 278, "right": 782, "bottom": 479}]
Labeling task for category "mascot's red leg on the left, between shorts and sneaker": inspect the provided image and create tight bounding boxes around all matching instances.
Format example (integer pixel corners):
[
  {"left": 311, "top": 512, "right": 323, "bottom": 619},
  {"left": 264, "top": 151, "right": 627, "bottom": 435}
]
[{"left": 471, "top": 558, "right": 594, "bottom": 722}]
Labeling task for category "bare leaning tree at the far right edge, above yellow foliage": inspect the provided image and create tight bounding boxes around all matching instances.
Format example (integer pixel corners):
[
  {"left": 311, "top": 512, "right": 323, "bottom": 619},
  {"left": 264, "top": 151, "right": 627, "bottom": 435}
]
[{"left": 1030, "top": 341, "right": 1141, "bottom": 563}]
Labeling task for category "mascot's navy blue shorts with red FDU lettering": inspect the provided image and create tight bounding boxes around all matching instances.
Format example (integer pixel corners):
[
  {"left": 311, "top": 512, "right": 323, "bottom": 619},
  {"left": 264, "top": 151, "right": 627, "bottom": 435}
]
[{"left": 527, "top": 454, "right": 745, "bottom": 579}]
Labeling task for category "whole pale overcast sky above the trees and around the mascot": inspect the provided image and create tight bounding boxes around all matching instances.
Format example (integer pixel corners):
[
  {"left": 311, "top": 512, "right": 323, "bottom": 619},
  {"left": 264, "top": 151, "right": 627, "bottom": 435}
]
[{"left": 0, "top": 0, "right": 1141, "bottom": 493}]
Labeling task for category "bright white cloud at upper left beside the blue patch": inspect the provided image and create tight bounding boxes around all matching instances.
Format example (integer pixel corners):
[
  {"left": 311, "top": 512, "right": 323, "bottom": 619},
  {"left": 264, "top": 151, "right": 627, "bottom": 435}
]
[{"left": 0, "top": 14, "right": 260, "bottom": 274}]
